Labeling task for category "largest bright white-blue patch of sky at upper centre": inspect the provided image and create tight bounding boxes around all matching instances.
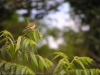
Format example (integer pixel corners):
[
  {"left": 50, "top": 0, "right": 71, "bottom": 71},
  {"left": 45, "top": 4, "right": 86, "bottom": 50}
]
[{"left": 43, "top": 2, "right": 78, "bottom": 32}]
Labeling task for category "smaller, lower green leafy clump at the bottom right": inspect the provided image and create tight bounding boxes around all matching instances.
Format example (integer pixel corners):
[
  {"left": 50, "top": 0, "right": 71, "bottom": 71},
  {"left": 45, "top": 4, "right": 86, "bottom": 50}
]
[{"left": 53, "top": 52, "right": 100, "bottom": 75}]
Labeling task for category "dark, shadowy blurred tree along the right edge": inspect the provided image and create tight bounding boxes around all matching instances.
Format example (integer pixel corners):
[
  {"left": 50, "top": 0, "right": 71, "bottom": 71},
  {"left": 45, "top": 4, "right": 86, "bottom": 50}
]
[{"left": 66, "top": 0, "right": 100, "bottom": 67}]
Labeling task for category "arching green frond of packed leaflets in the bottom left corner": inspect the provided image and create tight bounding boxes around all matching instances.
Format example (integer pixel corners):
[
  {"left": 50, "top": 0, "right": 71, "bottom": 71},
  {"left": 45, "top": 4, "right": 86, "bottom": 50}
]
[{"left": 0, "top": 60, "right": 35, "bottom": 75}]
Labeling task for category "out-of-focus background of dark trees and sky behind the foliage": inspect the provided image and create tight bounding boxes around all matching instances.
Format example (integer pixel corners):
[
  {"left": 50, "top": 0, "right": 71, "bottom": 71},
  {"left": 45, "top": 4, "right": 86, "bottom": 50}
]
[{"left": 0, "top": 0, "right": 100, "bottom": 74}]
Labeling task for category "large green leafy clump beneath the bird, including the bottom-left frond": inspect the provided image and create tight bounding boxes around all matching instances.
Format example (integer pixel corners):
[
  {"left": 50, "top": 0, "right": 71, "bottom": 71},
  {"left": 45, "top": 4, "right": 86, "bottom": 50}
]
[{"left": 0, "top": 25, "right": 53, "bottom": 75}]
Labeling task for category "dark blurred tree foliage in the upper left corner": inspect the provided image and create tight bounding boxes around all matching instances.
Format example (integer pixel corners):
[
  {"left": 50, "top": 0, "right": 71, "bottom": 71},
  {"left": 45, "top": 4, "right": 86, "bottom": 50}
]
[{"left": 0, "top": 0, "right": 62, "bottom": 30}]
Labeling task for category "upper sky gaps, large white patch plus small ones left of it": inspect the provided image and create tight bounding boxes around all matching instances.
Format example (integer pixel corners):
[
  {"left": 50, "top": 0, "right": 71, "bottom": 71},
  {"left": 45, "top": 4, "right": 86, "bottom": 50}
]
[{"left": 17, "top": 0, "right": 81, "bottom": 32}]
